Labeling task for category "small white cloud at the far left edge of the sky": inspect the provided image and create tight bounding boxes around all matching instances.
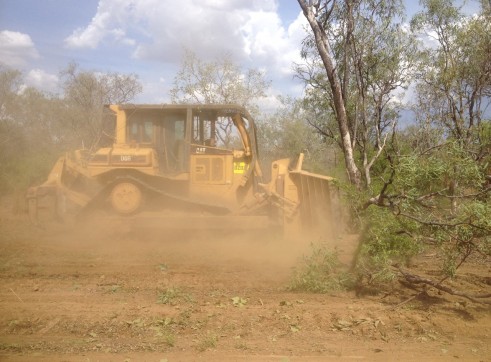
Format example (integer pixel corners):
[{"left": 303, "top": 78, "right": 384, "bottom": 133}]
[{"left": 0, "top": 30, "right": 39, "bottom": 68}]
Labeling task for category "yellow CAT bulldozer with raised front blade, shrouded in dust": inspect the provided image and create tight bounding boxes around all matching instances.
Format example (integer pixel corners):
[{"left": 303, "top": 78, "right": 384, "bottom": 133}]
[{"left": 26, "top": 104, "right": 333, "bottom": 232}]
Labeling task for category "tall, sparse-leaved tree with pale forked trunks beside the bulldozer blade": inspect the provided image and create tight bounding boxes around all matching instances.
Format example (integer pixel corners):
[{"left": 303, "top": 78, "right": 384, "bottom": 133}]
[{"left": 297, "top": 0, "right": 415, "bottom": 188}]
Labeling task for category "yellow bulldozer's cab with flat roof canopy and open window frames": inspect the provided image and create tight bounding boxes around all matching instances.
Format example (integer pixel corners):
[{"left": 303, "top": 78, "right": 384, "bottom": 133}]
[{"left": 109, "top": 105, "right": 257, "bottom": 183}]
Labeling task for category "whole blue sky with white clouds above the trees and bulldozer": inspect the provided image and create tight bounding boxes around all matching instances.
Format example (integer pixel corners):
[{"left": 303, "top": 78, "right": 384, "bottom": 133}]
[{"left": 0, "top": 0, "right": 480, "bottom": 109}]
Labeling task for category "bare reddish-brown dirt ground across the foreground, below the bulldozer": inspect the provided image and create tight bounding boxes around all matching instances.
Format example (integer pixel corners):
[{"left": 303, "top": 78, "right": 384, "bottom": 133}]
[{"left": 0, "top": 201, "right": 491, "bottom": 362}]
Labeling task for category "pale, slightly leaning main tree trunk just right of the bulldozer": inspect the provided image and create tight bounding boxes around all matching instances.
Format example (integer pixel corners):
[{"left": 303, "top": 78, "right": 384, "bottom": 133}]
[{"left": 298, "top": 0, "right": 361, "bottom": 188}]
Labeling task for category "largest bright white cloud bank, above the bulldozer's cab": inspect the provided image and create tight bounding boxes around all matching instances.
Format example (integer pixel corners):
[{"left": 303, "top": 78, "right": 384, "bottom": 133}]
[{"left": 65, "top": 0, "right": 306, "bottom": 100}]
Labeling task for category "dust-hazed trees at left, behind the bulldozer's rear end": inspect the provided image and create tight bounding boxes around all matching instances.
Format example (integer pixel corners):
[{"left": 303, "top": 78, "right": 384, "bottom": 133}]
[{"left": 0, "top": 64, "right": 141, "bottom": 196}]
